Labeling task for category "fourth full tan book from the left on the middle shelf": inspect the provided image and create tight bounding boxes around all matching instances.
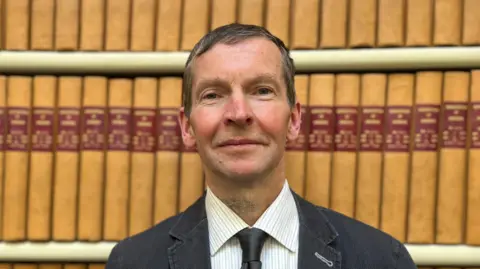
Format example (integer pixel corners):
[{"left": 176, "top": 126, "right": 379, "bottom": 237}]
[{"left": 77, "top": 76, "right": 107, "bottom": 241}]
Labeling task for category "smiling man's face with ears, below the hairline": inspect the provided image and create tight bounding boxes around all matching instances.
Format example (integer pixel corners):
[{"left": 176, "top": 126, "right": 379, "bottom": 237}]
[{"left": 180, "top": 38, "right": 300, "bottom": 179}]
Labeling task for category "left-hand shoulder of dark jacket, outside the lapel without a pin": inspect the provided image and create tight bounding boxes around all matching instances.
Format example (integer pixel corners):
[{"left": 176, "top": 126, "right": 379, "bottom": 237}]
[{"left": 105, "top": 214, "right": 181, "bottom": 269}]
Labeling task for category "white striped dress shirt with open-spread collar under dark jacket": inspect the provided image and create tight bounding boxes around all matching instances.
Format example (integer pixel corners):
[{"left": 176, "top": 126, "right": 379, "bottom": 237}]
[{"left": 205, "top": 180, "right": 299, "bottom": 269}]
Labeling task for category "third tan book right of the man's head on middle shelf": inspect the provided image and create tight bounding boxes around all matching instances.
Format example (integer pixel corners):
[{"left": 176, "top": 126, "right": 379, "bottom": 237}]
[{"left": 330, "top": 74, "right": 360, "bottom": 217}]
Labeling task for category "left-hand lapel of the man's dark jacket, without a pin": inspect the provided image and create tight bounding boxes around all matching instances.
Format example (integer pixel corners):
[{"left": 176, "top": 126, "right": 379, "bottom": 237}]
[{"left": 168, "top": 195, "right": 211, "bottom": 269}]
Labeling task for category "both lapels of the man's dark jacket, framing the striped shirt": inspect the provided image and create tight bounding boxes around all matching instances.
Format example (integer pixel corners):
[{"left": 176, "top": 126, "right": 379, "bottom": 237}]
[{"left": 168, "top": 191, "right": 341, "bottom": 269}]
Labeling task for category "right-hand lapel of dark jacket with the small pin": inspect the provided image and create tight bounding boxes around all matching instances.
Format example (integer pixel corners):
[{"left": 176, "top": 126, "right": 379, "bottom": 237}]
[{"left": 294, "top": 193, "right": 341, "bottom": 269}]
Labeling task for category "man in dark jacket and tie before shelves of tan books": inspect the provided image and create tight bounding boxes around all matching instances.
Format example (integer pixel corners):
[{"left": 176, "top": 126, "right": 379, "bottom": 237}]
[{"left": 106, "top": 24, "right": 416, "bottom": 269}]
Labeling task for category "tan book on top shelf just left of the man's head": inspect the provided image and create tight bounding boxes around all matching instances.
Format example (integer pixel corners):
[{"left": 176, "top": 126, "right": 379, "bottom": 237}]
[{"left": 155, "top": 0, "right": 182, "bottom": 51}]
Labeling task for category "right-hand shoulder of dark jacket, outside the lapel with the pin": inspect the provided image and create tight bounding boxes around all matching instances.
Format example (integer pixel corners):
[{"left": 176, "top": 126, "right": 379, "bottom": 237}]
[{"left": 317, "top": 206, "right": 417, "bottom": 269}]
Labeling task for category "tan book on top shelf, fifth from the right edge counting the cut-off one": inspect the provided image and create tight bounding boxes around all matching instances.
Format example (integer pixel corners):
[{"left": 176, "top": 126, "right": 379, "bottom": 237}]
[{"left": 348, "top": 0, "right": 377, "bottom": 48}]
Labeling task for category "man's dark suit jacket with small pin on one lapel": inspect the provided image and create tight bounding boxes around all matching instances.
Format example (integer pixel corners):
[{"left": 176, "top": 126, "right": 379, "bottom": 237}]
[{"left": 106, "top": 189, "right": 417, "bottom": 269}]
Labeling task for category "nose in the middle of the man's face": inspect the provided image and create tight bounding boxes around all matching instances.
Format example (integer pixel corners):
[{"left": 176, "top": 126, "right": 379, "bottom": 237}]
[{"left": 224, "top": 95, "right": 253, "bottom": 126}]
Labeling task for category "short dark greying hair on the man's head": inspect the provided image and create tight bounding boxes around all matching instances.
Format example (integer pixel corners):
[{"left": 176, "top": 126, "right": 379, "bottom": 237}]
[{"left": 182, "top": 23, "right": 296, "bottom": 117}]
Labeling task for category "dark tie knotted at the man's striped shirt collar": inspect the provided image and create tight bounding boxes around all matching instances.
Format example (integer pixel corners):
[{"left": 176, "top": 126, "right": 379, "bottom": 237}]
[{"left": 235, "top": 228, "right": 268, "bottom": 269}]
